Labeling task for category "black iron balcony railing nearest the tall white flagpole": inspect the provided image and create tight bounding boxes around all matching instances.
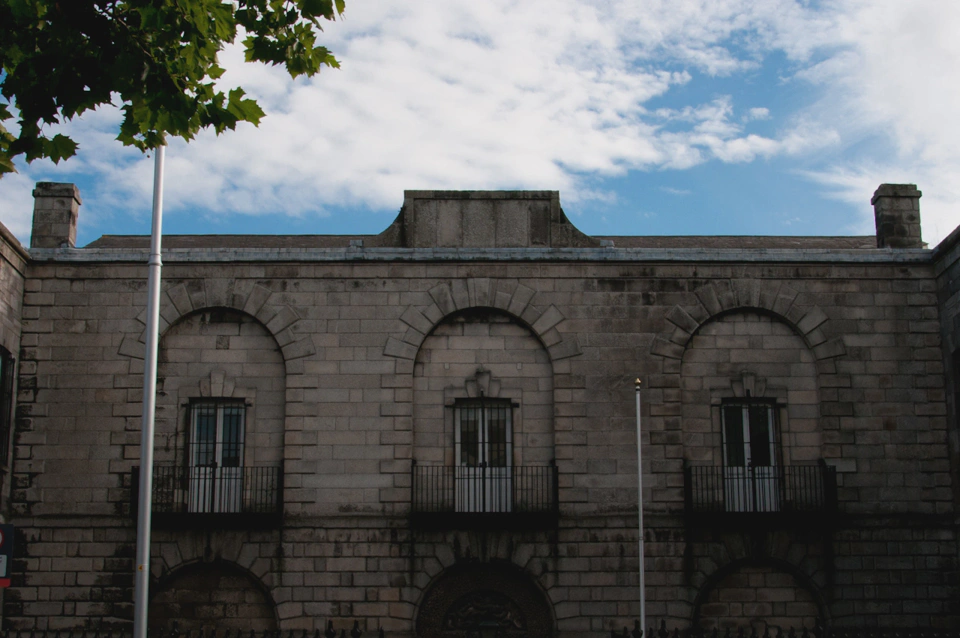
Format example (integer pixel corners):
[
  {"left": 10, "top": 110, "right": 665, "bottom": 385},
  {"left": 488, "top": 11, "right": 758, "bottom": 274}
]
[{"left": 131, "top": 465, "right": 283, "bottom": 525}]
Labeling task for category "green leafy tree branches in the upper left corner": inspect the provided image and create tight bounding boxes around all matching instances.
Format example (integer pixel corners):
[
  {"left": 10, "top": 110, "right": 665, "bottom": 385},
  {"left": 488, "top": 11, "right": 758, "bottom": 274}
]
[{"left": 0, "top": 0, "right": 344, "bottom": 174}]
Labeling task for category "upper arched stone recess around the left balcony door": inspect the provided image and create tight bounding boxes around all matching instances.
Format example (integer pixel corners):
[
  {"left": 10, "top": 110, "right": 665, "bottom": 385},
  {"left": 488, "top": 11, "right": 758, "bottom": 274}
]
[{"left": 154, "top": 308, "right": 286, "bottom": 467}]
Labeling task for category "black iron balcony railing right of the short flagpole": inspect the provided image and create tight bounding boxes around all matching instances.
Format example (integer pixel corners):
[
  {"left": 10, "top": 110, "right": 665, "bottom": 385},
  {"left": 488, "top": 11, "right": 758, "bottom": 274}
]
[{"left": 684, "top": 462, "right": 837, "bottom": 514}]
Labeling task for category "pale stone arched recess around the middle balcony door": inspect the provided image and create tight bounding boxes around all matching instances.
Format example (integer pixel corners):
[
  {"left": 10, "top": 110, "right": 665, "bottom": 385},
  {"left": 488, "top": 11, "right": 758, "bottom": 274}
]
[{"left": 413, "top": 308, "right": 555, "bottom": 466}]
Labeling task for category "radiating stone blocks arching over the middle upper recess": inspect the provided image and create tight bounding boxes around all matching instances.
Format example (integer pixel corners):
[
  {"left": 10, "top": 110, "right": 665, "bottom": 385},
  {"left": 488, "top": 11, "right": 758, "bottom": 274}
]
[{"left": 383, "top": 278, "right": 581, "bottom": 361}]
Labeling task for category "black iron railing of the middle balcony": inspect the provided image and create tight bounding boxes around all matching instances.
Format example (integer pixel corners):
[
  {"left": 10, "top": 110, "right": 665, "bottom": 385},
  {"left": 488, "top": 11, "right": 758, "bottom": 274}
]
[{"left": 411, "top": 462, "right": 559, "bottom": 527}]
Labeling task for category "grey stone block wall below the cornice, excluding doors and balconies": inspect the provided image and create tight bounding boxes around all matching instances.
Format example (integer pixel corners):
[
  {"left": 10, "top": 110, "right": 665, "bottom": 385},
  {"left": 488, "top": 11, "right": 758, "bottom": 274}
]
[{"left": 6, "top": 258, "right": 956, "bottom": 636}]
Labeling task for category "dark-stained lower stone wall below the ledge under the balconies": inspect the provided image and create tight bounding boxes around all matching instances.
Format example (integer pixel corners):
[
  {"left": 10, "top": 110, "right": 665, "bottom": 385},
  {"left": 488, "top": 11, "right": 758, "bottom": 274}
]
[{"left": 4, "top": 515, "right": 958, "bottom": 638}]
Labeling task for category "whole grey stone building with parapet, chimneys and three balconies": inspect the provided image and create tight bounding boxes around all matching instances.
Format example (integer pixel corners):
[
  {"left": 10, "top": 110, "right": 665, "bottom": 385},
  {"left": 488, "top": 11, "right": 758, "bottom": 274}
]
[{"left": 0, "top": 184, "right": 960, "bottom": 638}]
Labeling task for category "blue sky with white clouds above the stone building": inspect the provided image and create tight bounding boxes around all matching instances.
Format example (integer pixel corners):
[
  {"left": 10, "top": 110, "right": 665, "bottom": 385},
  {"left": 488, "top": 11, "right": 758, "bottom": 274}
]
[{"left": 0, "top": 0, "right": 960, "bottom": 245}]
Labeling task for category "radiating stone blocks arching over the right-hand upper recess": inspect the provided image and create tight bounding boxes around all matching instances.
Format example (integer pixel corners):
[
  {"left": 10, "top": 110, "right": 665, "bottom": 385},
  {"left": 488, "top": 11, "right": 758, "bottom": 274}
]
[{"left": 650, "top": 281, "right": 846, "bottom": 368}]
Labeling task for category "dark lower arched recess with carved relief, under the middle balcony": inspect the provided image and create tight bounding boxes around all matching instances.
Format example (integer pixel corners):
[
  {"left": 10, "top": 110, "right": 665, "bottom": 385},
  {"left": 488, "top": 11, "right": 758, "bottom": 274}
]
[{"left": 415, "top": 562, "right": 556, "bottom": 638}]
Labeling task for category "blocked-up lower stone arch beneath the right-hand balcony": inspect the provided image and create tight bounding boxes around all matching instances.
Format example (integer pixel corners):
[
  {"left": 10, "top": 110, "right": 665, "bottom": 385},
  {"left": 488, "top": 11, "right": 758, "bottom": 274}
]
[{"left": 693, "top": 558, "right": 830, "bottom": 634}]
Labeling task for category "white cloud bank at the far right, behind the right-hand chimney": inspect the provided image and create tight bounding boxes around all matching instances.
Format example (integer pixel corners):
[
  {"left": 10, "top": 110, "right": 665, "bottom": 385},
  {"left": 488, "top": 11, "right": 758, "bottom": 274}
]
[{"left": 801, "top": 0, "right": 960, "bottom": 245}]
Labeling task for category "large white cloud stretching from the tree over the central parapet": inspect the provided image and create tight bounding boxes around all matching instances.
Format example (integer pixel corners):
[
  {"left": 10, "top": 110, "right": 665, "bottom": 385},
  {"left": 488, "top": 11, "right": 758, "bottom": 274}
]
[{"left": 0, "top": 0, "right": 832, "bottom": 240}]
